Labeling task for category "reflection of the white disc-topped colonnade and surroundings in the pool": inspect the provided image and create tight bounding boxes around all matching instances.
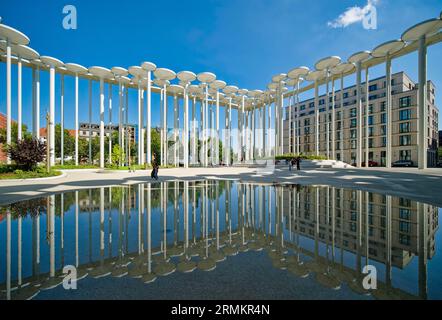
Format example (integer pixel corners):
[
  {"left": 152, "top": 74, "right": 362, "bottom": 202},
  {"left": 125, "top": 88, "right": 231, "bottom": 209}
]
[{"left": 0, "top": 181, "right": 438, "bottom": 299}]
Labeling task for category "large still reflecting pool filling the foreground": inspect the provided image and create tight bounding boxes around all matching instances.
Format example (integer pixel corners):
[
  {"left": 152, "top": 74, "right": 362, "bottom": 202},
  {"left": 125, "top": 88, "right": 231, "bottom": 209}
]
[{"left": 0, "top": 180, "right": 442, "bottom": 300}]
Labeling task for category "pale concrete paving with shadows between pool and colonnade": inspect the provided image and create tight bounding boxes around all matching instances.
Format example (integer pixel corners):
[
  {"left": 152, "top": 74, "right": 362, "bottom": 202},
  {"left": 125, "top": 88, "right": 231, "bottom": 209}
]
[{"left": 0, "top": 166, "right": 442, "bottom": 207}]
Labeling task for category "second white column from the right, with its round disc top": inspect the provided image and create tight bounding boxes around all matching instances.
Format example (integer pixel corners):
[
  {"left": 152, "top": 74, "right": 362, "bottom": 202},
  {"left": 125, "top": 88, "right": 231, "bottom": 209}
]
[{"left": 372, "top": 40, "right": 405, "bottom": 168}]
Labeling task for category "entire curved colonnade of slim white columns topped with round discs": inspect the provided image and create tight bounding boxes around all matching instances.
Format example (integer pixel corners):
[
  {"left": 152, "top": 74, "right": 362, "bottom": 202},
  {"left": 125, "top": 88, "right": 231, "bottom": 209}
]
[{"left": 0, "top": 17, "right": 442, "bottom": 169}]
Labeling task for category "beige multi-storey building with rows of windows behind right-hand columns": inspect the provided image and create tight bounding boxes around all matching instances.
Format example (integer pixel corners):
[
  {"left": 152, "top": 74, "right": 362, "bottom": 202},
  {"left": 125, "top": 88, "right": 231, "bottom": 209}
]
[{"left": 284, "top": 72, "right": 439, "bottom": 166}]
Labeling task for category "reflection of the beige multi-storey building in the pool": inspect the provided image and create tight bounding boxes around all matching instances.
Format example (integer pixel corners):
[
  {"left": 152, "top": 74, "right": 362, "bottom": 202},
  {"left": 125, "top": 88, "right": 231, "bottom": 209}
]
[{"left": 284, "top": 187, "right": 439, "bottom": 268}]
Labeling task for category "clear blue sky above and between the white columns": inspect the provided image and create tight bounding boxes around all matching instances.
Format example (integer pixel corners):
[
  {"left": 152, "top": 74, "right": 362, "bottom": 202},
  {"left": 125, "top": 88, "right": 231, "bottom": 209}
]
[{"left": 0, "top": 0, "right": 442, "bottom": 128}]
